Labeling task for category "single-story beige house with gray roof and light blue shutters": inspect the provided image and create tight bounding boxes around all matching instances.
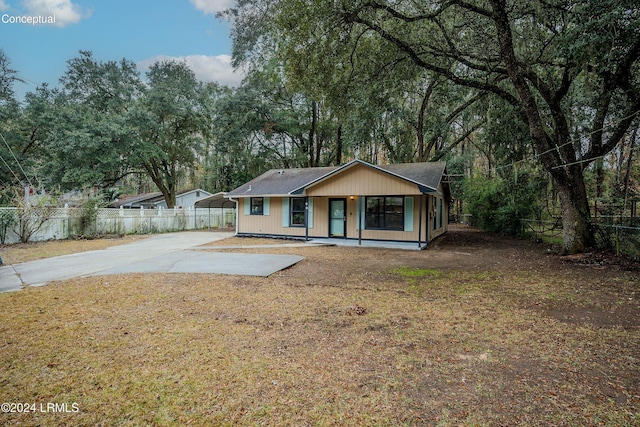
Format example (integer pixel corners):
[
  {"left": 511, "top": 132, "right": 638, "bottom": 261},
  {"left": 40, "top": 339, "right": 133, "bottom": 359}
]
[{"left": 225, "top": 160, "right": 451, "bottom": 246}]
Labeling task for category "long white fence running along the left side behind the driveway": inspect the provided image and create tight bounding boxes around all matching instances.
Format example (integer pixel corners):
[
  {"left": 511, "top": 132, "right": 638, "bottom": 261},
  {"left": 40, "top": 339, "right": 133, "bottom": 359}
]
[{"left": 0, "top": 207, "right": 236, "bottom": 244}]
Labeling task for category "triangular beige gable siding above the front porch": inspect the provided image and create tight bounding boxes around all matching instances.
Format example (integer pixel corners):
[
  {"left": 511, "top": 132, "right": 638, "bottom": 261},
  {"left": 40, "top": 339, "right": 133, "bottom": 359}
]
[{"left": 307, "top": 165, "right": 420, "bottom": 197}]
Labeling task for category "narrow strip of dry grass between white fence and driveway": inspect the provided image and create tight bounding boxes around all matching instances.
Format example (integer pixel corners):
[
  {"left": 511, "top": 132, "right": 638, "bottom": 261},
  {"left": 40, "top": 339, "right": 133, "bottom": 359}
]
[{"left": 0, "top": 235, "right": 148, "bottom": 264}]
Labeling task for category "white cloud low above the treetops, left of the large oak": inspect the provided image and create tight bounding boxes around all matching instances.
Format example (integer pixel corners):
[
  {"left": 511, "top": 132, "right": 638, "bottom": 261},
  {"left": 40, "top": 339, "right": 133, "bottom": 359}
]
[{"left": 138, "top": 55, "right": 244, "bottom": 87}]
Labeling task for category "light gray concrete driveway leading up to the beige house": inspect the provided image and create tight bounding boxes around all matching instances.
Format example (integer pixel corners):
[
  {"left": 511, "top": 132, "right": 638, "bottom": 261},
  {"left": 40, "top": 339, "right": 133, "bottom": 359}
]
[{"left": 0, "top": 231, "right": 304, "bottom": 292}]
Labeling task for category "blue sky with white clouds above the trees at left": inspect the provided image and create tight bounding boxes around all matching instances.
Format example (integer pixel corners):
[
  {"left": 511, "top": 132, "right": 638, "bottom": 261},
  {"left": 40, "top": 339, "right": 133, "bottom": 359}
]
[{"left": 0, "top": 0, "right": 242, "bottom": 98}]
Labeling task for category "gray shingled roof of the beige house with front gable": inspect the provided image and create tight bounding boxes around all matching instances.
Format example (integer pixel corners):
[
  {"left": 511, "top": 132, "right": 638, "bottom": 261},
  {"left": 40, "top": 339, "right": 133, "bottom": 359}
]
[{"left": 226, "top": 160, "right": 446, "bottom": 197}]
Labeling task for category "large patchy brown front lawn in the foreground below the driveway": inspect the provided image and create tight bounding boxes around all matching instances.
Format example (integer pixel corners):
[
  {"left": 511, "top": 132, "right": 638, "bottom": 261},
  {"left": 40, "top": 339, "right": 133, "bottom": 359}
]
[{"left": 0, "top": 229, "right": 640, "bottom": 426}]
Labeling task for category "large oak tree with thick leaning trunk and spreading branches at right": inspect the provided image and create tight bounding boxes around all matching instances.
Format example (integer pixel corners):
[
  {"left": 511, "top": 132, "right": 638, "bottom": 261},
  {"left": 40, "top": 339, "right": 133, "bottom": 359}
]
[{"left": 230, "top": 0, "right": 640, "bottom": 252}]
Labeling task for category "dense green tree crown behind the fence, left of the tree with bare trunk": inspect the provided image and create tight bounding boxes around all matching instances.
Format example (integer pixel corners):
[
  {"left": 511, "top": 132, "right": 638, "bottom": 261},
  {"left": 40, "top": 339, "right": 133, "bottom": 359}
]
[{"left": 36, "top": 51, "right": 144, "bottom": 191}]
